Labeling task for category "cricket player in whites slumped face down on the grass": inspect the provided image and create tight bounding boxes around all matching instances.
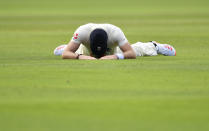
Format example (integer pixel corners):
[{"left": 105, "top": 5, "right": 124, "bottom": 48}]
[{"left": 54, "top": 23, "right": 176, "bottom": 60}]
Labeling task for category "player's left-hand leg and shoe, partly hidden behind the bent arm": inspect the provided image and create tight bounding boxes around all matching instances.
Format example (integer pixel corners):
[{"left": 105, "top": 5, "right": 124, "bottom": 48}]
[{"left": 54, "top": 44, "right": 89, "bottom": 56}]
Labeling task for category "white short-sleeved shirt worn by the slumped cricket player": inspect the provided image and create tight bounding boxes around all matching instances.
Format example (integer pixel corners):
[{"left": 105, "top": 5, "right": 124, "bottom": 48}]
[{"left": 71, "top": 23, "right": 128, "bottom": 55}]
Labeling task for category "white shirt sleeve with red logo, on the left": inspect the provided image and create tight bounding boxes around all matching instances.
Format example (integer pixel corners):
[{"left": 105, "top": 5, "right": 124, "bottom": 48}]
[{"left": 71, "top": 26, "right": 86, "bottom": 44}]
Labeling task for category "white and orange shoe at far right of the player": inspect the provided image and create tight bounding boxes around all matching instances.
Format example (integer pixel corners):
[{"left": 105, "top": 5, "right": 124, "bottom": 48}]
[{"left": 151, "top": 41, "right": 176, "bottom": 56}]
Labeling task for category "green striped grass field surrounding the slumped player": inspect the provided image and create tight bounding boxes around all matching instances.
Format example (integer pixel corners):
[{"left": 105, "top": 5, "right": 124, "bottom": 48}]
[{"left": 0, "top": 0, "right": 209, "bottom": 131}]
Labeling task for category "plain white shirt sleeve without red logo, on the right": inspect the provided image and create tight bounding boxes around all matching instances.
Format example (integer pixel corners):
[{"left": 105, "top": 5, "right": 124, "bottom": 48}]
[{"left": 114, "top": 27, "right": 128, "bottom": 46}]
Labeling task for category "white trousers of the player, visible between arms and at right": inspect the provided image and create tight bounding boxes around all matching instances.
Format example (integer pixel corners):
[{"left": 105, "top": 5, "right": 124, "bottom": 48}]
[{"left": 76, "top": 42, "right": 157, "bottom": 56}]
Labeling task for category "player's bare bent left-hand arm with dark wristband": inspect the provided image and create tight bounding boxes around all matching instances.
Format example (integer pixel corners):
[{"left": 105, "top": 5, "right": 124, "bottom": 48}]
[{"left": 62, "top": 41, "right": 96, "bottom": 60}]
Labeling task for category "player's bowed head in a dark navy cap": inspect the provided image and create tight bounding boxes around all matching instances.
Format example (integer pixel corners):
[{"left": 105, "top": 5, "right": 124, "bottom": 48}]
[{"left": 90, "top": 29, "right": 108, "bottom": 58}]
